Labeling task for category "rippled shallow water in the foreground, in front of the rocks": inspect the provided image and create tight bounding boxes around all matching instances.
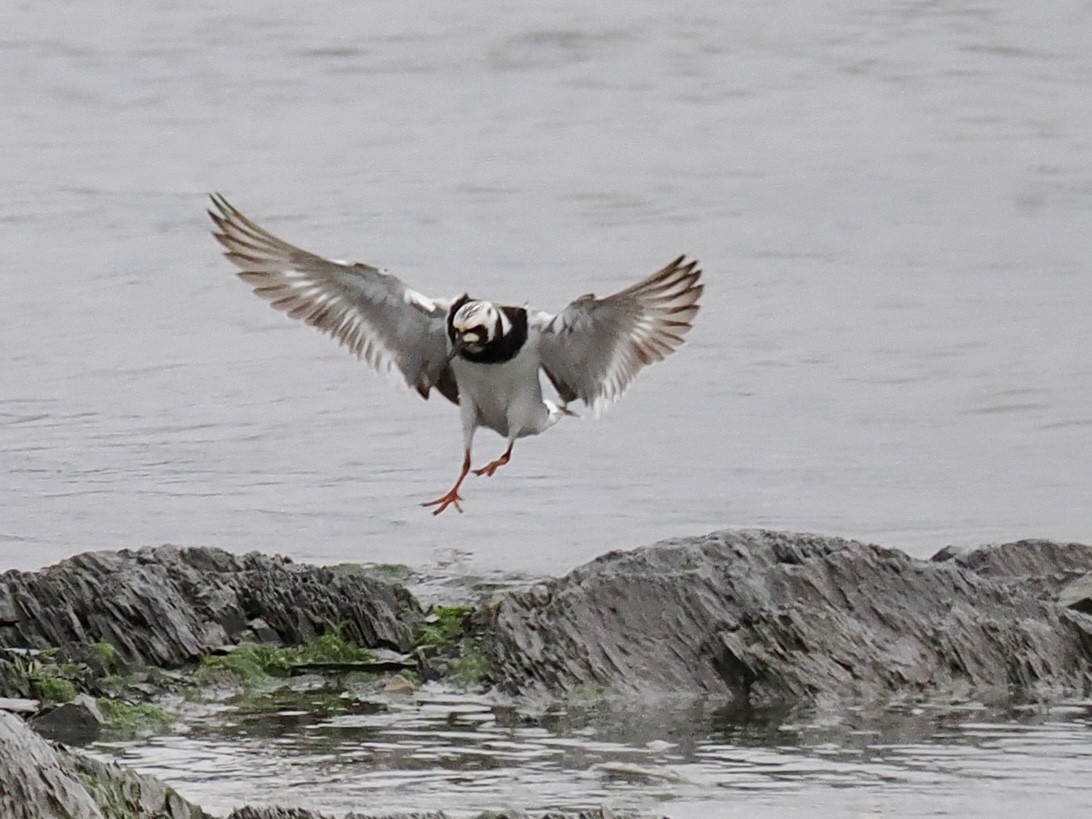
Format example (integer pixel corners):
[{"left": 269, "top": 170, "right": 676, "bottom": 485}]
[{"left": 91, "top": 687, "right": 1092, "bottom": 818}]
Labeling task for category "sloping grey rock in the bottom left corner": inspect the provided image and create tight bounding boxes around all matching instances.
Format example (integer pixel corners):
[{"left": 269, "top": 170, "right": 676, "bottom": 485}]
[{"left": 0, "top": 712, "right": 211, "bottom": 819}]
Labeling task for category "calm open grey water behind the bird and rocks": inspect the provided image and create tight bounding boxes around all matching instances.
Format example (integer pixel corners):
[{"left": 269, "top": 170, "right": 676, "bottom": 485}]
[{"left": 0, "top": 0, "right": 1092, "bottom": 812}]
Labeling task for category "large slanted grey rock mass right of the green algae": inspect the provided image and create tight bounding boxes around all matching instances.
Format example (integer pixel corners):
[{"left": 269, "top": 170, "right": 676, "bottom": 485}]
[{"left": 483, "top": 531, "right": 1092, "bottom": 704}]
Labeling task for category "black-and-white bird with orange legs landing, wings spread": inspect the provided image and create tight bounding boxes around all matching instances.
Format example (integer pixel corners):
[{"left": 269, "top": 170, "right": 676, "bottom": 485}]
[{"left": 209, "top": 193, "right": 704, "bottom": 514}]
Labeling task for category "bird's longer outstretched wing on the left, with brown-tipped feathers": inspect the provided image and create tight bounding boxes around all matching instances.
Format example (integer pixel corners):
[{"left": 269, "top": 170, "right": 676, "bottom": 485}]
[{"left": 209, "top": 194, "right": 459, "bottom": 404}]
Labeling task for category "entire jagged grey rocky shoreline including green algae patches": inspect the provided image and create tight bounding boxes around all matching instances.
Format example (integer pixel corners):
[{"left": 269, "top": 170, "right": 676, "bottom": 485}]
[{"left": 0, "top": 531, "right": 1092, "bottom": 819}]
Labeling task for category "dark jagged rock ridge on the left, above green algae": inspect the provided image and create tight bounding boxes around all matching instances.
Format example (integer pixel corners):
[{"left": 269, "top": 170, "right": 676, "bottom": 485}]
[{"left": 0, "top": 546, "right": 420, "bottom": 677}]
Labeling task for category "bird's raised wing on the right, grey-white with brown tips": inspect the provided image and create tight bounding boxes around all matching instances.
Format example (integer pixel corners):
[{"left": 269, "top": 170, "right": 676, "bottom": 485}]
[{"left": 535, "top": 256, "right": 703, "bottom": 415}]
